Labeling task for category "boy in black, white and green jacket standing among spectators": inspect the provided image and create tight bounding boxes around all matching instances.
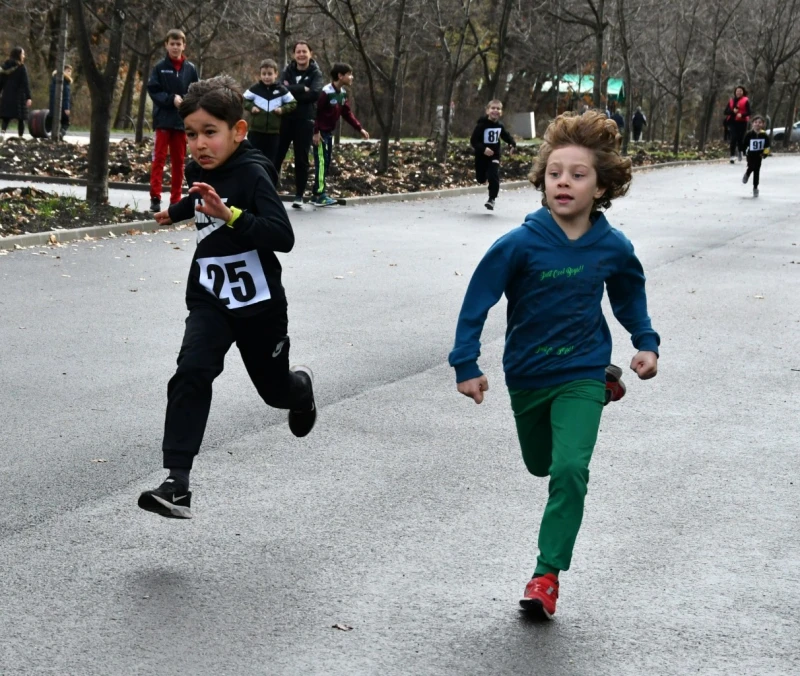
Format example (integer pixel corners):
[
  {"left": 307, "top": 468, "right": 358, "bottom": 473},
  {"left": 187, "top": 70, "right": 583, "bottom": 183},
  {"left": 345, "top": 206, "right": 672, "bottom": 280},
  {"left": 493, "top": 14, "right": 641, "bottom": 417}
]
[{"left": 244, "top": 59, "right": 297, "bottom": 167}]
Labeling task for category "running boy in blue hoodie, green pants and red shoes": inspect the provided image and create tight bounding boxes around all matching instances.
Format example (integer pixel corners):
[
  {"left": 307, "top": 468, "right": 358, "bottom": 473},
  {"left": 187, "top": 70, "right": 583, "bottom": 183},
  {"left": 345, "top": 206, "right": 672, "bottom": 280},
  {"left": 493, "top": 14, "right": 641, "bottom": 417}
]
[{"left": 450, "top": 112, "right": 660, "bottom": 619}]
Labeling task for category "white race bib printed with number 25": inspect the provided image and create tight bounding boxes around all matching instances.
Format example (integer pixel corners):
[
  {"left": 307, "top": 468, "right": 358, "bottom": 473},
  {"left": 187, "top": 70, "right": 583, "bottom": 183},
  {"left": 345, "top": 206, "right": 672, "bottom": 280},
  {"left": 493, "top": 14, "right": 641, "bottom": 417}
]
[{"left": 197, "top": 251, "right": 272, "bottom": 310}]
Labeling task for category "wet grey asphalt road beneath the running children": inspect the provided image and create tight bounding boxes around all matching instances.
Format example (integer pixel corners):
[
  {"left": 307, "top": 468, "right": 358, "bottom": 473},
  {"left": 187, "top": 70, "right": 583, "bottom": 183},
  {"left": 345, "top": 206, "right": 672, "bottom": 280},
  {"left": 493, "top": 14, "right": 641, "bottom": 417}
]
[{"left": 0, "top": 158, "right": 800, "bottom": 676}]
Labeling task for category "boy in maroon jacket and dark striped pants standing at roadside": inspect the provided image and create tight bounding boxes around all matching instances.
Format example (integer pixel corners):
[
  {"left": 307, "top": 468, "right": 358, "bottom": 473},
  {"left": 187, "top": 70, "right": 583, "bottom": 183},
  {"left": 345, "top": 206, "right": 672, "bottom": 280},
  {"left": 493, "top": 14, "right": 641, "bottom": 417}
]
[{"left": 311, "top": 63, "right": 369, "bottom": 207}]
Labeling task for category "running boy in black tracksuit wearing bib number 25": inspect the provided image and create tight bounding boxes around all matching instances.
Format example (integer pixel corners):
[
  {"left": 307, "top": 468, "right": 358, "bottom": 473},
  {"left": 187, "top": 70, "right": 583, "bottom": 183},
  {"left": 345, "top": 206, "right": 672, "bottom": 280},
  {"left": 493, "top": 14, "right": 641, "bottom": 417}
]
[{"left": 139, "top": 76, "right": 317, "bottom": 519}]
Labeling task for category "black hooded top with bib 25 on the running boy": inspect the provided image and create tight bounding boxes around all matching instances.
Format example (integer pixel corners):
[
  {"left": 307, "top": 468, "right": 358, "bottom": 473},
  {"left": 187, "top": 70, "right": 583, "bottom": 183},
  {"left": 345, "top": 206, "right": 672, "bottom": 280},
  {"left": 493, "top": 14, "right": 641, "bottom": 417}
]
[{"left": 169, "top": 141, "right": 294, "bottom": 317}]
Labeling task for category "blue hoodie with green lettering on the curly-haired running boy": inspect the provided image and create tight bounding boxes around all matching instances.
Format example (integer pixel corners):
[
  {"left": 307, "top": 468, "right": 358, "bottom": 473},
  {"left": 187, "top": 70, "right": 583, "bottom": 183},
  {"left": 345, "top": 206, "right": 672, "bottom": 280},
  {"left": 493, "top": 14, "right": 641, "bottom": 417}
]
[{"left": 449, "top": 208, "right": 660, "bottom": 389}]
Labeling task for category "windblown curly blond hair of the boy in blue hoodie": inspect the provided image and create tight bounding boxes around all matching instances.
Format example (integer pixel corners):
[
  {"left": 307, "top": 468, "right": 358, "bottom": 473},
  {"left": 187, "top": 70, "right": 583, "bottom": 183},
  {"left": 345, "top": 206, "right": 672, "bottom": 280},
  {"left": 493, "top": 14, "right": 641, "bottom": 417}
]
[{"left": 528, "top": 110, "right": 631, "bottom": 211}]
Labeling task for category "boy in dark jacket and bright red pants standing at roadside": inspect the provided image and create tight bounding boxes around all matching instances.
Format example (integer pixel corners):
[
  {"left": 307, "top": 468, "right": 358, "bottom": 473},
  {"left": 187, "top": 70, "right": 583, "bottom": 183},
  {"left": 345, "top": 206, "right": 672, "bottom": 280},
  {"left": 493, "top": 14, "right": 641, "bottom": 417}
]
[{"left": 147, "top": 28, "right": 199, "bottom": 211}]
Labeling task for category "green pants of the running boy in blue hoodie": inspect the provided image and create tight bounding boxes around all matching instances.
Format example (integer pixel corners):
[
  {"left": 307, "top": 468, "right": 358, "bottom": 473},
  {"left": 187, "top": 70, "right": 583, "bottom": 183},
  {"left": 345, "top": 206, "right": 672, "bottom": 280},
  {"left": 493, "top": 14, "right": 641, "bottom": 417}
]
[{"left": 509, "top": 380, "right": 605, "bottom": 575}]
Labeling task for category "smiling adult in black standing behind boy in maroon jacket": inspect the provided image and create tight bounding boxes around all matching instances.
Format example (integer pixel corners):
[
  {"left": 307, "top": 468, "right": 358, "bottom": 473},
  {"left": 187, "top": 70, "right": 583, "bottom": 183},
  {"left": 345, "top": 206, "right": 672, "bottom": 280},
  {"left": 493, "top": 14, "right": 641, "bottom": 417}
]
[{"left": 276, "top": 40, "right": 323, "bottom": 209}]
